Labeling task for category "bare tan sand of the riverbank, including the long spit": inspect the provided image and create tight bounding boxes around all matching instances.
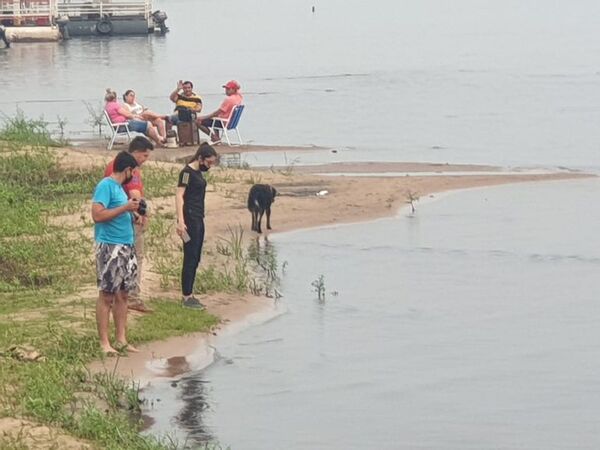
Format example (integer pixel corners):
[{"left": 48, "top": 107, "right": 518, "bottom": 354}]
[{"left": 79, "top": 142, "right": 591, "bottom": 386}]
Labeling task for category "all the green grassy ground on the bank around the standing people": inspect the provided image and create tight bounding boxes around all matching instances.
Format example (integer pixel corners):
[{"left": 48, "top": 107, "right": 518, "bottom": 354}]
[{"left": 0, "top": 117, "right": 245, "bottom": 449}]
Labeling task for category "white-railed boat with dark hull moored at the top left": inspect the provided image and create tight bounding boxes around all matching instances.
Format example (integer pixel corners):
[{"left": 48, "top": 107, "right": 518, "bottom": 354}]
[{"left": 0, "top": 0, "right": 168, "bottom": 40}]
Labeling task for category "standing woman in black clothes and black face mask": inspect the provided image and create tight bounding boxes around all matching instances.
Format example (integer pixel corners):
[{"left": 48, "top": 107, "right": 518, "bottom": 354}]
[{"left": 175, "top": 142, "right": 218, "bottom": 309}]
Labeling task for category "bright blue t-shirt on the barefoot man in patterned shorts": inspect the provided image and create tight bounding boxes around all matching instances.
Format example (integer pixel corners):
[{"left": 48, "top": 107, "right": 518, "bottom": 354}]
[{"left": 92, "top": 177, "right": 134, "bottom": 245}]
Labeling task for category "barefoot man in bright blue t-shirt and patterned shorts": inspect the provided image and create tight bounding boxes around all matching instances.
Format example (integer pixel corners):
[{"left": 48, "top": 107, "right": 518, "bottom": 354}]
[{"left": 92, "top": 152, "right": 139, "bottom": 354}]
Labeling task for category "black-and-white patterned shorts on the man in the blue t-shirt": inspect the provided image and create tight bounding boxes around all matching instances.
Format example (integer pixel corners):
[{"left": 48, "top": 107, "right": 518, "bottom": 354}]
[{"left": 96, "top": 243, "right": 138, "bottom": 294}]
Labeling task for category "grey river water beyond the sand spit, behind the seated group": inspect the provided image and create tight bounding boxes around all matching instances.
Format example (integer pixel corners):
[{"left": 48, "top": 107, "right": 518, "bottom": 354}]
[{"left": 0, "top": 0, "right": 600, "bottom": 168}]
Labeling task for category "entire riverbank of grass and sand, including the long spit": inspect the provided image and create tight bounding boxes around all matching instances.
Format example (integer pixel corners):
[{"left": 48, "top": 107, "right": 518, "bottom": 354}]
[{"left": 0, "top": 140, "right": 596, "bottom": 448}]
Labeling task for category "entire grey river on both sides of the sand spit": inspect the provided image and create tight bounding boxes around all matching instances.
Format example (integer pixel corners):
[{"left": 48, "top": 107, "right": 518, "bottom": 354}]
[{"left": 0, "top": 0, "right": 600, "bottom": 450}]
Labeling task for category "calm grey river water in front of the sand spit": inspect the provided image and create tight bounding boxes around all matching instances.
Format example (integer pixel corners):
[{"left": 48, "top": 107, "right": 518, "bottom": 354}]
[{"left": 147, "top": 180, "right": 600, "bottom": 450}]
